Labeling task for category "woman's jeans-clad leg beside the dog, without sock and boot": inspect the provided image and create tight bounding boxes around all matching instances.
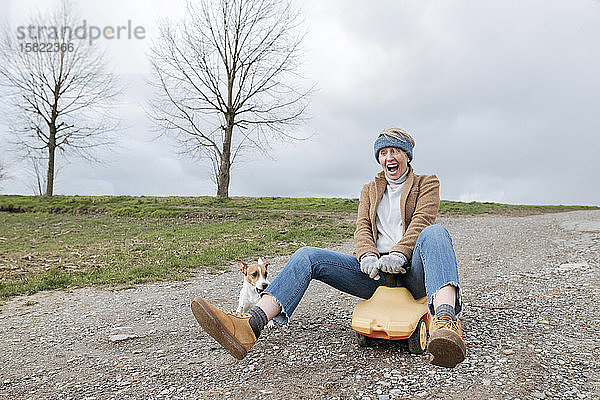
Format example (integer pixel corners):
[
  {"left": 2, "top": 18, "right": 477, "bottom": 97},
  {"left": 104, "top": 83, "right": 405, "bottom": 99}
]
[{"left": 258, "top": 247, "right": 385, "bottom": 324}]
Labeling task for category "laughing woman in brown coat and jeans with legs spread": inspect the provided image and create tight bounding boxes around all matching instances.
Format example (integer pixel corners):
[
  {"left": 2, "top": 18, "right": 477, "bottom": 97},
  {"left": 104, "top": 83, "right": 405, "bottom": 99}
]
[{"left": 192, "top": 128, "right": 465, "bottom": 367}]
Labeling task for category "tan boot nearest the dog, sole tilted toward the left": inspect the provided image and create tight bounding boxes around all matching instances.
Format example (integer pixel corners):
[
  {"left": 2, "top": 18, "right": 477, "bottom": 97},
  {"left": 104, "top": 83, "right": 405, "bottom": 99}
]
[{"left": 192, "top": 297, "right": 256, "bottom": 360}]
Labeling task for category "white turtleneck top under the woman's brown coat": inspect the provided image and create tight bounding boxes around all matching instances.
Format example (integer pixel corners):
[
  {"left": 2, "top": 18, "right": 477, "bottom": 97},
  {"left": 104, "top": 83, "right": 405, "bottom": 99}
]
[{"left": 375, "top": 168, "right": 409, "bottom": 253}]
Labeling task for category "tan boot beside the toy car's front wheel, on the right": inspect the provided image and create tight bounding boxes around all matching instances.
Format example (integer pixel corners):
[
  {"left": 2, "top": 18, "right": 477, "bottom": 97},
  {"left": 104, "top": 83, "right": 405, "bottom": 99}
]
[{"left": 427, "top": 315, "right": 466, "bottom": 368}]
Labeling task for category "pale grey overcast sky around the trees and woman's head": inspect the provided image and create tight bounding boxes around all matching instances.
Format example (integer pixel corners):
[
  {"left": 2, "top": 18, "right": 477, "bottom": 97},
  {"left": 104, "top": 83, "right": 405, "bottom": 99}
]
[{"left": 0, "top": 0, "right": 600, "bottom": 205}]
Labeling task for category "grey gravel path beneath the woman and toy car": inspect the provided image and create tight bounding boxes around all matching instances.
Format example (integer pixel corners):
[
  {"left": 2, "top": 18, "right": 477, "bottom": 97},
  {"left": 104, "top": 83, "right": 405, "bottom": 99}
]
[{"left": 0, "top": 211, "right": 600, "bottom": 400}]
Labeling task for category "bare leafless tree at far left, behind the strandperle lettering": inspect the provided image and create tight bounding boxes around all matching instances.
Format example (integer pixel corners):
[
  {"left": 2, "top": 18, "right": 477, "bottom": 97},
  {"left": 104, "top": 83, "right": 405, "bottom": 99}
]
[{"left": 0, "top": 1, "right": 121, "bottom": 196}]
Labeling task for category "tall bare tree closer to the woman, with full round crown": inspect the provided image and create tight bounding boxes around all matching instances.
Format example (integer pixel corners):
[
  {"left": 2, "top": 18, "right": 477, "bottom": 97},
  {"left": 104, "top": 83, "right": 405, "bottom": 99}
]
[{"left": 148, "top": 0, "right": 312, "bottom": 197}]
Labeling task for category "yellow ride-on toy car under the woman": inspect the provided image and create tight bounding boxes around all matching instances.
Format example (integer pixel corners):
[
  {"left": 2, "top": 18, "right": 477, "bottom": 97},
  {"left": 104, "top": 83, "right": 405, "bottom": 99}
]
[{"left": 352, "top": 286, "right": 431, "bottom": 354}]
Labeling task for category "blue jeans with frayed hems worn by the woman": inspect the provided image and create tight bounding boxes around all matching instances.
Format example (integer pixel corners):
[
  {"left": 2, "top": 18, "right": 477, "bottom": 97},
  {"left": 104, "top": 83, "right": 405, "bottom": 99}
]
[{"left": 264, "top": 225, "right": 462, "bottom": 325}]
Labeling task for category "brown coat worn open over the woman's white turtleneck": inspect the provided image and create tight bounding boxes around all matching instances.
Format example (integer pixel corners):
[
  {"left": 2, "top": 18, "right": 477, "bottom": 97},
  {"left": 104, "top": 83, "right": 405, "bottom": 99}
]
[{"left": 354, "top": 166, "right": 440, "bottom": 260}]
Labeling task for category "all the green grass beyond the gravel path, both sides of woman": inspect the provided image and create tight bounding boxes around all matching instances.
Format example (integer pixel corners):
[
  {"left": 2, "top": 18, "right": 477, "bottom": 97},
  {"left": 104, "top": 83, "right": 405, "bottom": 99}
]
[{"left": 0, "top": 196, "right": 599, "bottom": 298}]
